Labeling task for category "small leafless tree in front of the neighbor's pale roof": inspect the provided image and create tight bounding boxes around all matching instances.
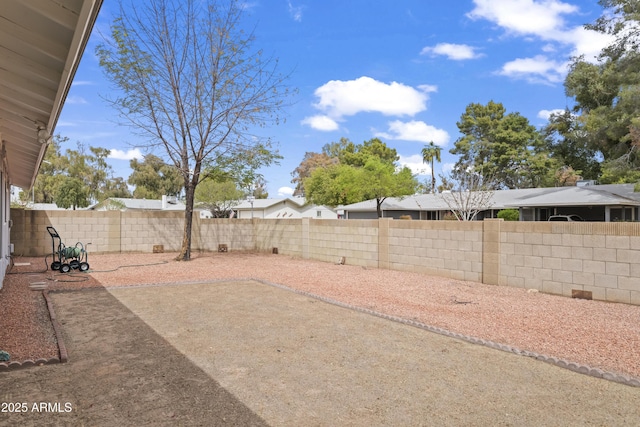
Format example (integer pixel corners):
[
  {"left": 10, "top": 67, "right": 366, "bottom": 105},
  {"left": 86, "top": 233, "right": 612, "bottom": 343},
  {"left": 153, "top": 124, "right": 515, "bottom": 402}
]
[{"left": 440, "top": 170, "right": 495, "bottom": 221}]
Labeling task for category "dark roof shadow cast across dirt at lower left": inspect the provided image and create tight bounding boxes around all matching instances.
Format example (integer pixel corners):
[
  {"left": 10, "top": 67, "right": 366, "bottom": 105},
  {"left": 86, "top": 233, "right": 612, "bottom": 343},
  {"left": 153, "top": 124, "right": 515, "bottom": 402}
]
[{"left": 0, "top": 288, "right": 266, "bottom": 426}]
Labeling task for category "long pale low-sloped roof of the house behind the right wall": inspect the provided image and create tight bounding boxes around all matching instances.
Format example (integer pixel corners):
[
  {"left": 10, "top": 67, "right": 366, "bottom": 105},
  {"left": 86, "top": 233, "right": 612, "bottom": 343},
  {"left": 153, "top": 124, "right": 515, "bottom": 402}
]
[{"left": 340, "top": 184, "right": 640, "bottom": 212}]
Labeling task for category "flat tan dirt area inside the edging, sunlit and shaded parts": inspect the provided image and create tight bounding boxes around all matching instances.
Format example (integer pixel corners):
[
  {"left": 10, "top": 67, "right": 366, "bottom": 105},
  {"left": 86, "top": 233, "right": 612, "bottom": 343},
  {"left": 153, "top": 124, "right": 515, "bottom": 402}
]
[{"left": 0, "top": 280, "right": 640, "bottom": 426}]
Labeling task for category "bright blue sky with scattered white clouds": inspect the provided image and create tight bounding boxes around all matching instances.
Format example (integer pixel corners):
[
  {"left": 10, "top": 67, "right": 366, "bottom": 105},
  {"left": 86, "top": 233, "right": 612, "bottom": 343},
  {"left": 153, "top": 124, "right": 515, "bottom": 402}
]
[{"left": 56, "top": 0, "right": 608, "bottom": 197}]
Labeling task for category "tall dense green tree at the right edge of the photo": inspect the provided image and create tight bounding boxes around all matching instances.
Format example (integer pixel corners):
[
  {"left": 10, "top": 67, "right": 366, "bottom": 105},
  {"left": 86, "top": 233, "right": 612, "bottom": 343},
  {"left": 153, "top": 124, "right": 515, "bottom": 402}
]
[{"left": 565, "top": 0, "right": 640, "bottom": 182}]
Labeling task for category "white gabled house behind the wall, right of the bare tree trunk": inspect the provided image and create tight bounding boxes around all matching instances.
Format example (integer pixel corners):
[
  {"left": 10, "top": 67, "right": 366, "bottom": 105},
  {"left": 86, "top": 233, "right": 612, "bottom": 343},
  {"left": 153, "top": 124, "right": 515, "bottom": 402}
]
[{"left": 233, "top": 197, "right": 338, "bottom": 219}]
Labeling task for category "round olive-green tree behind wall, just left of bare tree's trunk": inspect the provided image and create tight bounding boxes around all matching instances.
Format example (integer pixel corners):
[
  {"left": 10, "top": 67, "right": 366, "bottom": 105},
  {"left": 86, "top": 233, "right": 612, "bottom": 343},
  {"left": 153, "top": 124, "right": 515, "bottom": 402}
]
[{"left": 128, "top": 154, "right": 184, "bottom": 199}]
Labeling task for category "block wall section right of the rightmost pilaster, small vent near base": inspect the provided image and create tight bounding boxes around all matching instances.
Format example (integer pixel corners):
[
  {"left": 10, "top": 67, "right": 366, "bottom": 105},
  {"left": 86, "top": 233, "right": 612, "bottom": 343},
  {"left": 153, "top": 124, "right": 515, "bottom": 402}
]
[{"left": 499, "top": 222, "right": 640, "bottom": 305}]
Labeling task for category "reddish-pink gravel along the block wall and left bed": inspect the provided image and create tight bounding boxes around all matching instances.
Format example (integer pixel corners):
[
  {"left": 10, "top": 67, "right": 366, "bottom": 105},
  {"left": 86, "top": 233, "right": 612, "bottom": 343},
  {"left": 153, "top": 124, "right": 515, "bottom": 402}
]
[{"left": 0, "top": 252, "right": 640, "bottom": 378}]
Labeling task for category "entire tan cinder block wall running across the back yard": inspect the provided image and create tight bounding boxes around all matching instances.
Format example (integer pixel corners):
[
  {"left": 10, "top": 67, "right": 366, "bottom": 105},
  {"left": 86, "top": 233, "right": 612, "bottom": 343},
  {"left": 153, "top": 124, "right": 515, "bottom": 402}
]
[{"left": 11, "top": 209, "right": 640, "bottom": 305}]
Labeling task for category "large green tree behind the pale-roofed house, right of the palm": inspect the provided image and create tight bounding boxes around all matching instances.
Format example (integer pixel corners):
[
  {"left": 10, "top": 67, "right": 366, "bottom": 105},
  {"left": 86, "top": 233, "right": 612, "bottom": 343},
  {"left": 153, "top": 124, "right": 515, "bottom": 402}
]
[{"left": 450, "top": 101, "right": 555, "bottom": 189}]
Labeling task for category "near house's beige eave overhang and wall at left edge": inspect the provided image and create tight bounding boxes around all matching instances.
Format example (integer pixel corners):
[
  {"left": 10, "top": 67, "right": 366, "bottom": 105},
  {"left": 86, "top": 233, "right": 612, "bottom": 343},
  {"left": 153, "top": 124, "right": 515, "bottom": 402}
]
[{"left": 0, "top": 0, "right": 102, "bottom": 287}]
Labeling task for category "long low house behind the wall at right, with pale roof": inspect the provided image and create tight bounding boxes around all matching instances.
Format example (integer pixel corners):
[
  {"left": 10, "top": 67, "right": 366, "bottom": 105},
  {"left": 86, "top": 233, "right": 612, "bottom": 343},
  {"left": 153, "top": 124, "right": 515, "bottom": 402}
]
[{"left": 339, "top": 184, "right": 640, "bottom": 222}]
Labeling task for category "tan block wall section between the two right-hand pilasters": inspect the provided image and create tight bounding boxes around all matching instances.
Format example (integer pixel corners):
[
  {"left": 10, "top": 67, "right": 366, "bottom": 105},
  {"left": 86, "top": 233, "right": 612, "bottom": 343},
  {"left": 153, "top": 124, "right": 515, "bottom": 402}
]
[{"left": 389, "top": 221, "right": 483, "bottom": 282}]
